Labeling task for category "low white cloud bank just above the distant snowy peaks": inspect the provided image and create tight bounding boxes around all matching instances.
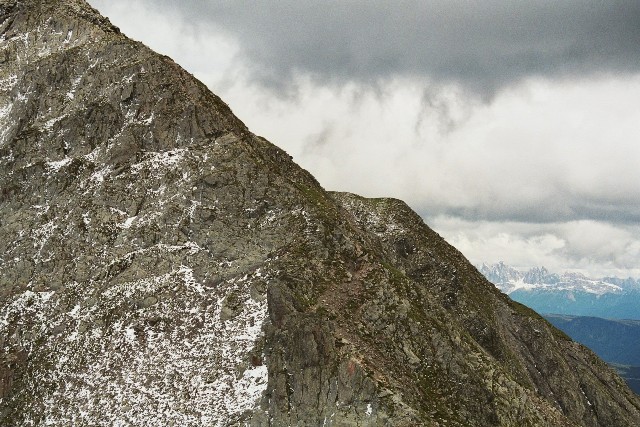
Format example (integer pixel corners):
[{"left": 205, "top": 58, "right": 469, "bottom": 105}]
[{"left": 431, "top": 216, "right": 640, "bottom": 278}]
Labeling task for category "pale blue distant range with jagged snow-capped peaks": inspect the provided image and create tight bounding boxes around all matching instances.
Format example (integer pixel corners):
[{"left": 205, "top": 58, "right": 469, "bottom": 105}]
[{"left": 479, "top": 262, "right": 640, "bottom": 320}]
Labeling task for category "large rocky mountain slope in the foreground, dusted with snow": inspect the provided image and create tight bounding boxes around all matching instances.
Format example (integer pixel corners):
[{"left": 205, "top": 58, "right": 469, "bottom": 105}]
[{"left": 0, "top": 0, "right": 640, "bottom": 427}]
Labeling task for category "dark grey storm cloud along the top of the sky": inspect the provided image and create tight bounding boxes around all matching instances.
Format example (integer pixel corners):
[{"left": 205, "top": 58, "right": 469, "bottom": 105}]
[{"left": 147, "top": 0, "right": 640, "bottom": 94}]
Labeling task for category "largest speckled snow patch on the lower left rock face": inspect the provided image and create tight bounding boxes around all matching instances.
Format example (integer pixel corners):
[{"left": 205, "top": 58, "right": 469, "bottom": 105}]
[{"left": 0, "top": 265, "right": 269, "bottom": 427}]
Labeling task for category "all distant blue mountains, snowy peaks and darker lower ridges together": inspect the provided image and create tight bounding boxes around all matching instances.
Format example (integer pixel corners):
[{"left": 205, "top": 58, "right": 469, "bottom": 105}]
[{"left": 478, "top": 262, "right": 640, "bottom": 394}]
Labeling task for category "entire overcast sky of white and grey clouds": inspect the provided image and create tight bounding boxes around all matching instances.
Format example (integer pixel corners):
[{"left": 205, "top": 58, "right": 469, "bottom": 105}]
[{"left": 89, "top": 0, "right": 640, "bottom": 277}]
